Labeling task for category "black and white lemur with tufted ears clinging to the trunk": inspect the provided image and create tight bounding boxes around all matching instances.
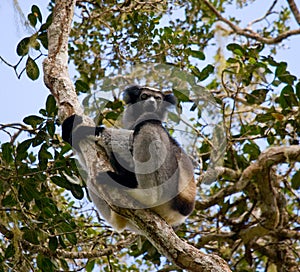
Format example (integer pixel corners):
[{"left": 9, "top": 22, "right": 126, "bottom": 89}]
[{"left": 62, "top": 86, "right": 196, "bottom": 231}]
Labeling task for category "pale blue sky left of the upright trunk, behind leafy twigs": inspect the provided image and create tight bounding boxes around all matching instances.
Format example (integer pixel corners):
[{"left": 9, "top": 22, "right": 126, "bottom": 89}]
[{"left": 0, "top": 0, "right": 49, "bottom": 124}]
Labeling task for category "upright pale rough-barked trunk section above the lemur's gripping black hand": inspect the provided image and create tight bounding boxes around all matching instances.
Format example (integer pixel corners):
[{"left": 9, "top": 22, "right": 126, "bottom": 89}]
[{"left": 43, "top": 0, "right": 83, "bottom": 120}]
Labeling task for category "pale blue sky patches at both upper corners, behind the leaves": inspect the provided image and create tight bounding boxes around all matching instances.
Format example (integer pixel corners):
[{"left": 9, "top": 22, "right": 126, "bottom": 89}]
[{"left": 0, "top": 0, "right": 300, "bottom": 133}]
